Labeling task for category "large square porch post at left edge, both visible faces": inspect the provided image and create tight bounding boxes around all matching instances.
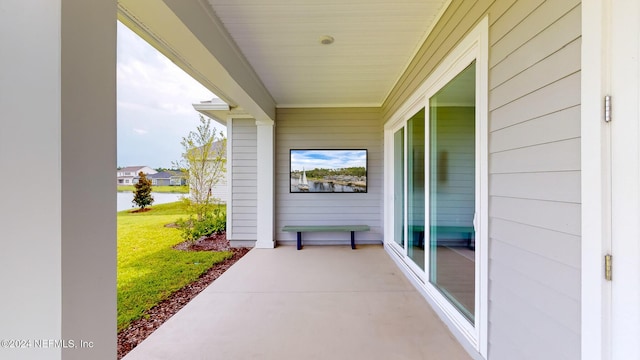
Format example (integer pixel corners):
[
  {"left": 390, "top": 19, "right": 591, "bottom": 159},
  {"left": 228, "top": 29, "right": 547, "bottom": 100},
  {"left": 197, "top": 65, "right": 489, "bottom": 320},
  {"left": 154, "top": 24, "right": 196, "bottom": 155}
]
[{"left": 0, "top": 0, "right": 117, "bottom": 360}]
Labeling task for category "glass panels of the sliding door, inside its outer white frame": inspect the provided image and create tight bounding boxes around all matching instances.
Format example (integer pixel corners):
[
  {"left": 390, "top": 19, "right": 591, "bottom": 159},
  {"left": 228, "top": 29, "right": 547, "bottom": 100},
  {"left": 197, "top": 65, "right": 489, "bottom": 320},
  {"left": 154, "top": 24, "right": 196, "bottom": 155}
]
[{"left": 392, "top": 62, "right": 479, "bottom": 323}]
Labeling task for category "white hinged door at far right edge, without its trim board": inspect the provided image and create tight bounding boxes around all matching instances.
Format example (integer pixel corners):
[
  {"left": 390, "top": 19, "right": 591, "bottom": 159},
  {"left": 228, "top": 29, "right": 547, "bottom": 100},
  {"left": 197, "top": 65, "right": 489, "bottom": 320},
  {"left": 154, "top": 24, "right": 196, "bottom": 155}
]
[{"left": 611, "top": 0, "right": 640, "bottom": 359}]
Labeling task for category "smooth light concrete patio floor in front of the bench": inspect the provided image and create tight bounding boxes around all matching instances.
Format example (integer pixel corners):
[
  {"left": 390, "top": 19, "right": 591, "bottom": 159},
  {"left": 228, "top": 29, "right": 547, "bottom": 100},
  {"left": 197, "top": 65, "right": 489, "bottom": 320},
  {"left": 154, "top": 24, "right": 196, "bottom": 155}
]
[{"left": 124, "top": 245, "right": 470, "bottom": 360}]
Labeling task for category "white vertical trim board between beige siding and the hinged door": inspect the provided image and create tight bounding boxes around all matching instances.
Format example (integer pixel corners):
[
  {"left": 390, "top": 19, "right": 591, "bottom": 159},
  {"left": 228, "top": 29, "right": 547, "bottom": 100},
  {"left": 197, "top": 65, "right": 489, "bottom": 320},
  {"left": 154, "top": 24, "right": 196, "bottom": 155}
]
[{"left": 580, "top": 0, "right": 611, "bottom": 360}]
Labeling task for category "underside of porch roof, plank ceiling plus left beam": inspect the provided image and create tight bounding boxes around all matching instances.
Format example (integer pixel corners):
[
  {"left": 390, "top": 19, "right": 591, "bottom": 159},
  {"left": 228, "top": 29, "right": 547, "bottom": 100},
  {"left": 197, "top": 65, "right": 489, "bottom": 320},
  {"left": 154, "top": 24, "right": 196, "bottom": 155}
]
[{"left": 118, "top": 0, "right": 450, "bottom": 124}]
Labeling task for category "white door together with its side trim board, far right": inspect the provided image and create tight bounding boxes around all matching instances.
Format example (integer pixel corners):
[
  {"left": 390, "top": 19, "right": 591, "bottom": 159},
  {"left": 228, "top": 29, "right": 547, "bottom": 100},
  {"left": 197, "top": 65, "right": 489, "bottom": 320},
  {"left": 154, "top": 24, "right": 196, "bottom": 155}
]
[{"left": 581, "top": 0, "right": 640, "bottom": 360}]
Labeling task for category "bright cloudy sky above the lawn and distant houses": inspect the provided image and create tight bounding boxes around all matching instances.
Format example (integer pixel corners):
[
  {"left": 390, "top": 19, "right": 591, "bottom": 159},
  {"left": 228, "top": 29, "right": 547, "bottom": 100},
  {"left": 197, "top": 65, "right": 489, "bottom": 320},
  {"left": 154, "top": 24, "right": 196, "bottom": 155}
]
[{"left": 117, "top": 22, "right": 221, "bottom": 168}]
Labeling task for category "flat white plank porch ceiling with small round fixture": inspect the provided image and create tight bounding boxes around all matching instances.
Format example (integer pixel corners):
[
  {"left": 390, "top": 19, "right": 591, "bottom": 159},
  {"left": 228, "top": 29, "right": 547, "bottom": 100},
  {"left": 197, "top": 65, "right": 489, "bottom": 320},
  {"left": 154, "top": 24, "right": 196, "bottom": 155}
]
[{"left": 208, "top": 0, "right": 449, "bottom": 107}]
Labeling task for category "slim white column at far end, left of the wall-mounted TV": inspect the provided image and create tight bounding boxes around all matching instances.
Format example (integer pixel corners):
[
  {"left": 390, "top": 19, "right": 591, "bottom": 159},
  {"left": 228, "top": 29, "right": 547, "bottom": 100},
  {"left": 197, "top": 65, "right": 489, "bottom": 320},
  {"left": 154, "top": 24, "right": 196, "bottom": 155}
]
[{"left": 256, "top": 121, "right": 275, "bottom": 249}]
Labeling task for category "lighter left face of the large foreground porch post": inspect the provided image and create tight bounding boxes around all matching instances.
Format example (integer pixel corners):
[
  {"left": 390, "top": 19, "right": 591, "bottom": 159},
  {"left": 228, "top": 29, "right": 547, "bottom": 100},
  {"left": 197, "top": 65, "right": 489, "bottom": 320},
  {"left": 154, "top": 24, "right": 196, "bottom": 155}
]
[{"left": 0, "top": 0, "right": 62, "bottom": 359}]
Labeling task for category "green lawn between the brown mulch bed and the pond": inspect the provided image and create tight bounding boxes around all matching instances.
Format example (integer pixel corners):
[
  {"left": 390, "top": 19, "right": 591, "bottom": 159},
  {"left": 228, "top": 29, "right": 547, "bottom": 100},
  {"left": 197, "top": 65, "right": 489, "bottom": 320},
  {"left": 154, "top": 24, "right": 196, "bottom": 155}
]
[{"left": 117, "top": 202, "right": 232, "bottom": 331}]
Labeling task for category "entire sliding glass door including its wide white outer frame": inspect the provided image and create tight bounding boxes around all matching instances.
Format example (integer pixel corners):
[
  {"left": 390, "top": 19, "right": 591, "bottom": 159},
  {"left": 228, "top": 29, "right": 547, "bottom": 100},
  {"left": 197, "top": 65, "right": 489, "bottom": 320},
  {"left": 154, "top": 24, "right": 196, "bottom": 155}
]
[{"left": 385, "top": 19, "right": 489, "bottom": 356}]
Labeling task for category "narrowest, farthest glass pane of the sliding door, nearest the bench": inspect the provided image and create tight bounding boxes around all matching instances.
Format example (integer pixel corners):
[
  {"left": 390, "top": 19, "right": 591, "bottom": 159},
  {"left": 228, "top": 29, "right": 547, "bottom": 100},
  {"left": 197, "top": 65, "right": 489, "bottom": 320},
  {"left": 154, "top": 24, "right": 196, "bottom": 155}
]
[{"left": 393, "top": 128, "right": 404, "bottom": 248}]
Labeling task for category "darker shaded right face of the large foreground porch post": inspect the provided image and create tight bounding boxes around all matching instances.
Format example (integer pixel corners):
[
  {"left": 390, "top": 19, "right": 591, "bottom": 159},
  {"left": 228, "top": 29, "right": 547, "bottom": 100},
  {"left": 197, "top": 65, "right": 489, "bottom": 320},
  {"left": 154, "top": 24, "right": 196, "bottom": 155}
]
[{"left": 60, "top": 0, "right": 117, "bottom": 360}]
